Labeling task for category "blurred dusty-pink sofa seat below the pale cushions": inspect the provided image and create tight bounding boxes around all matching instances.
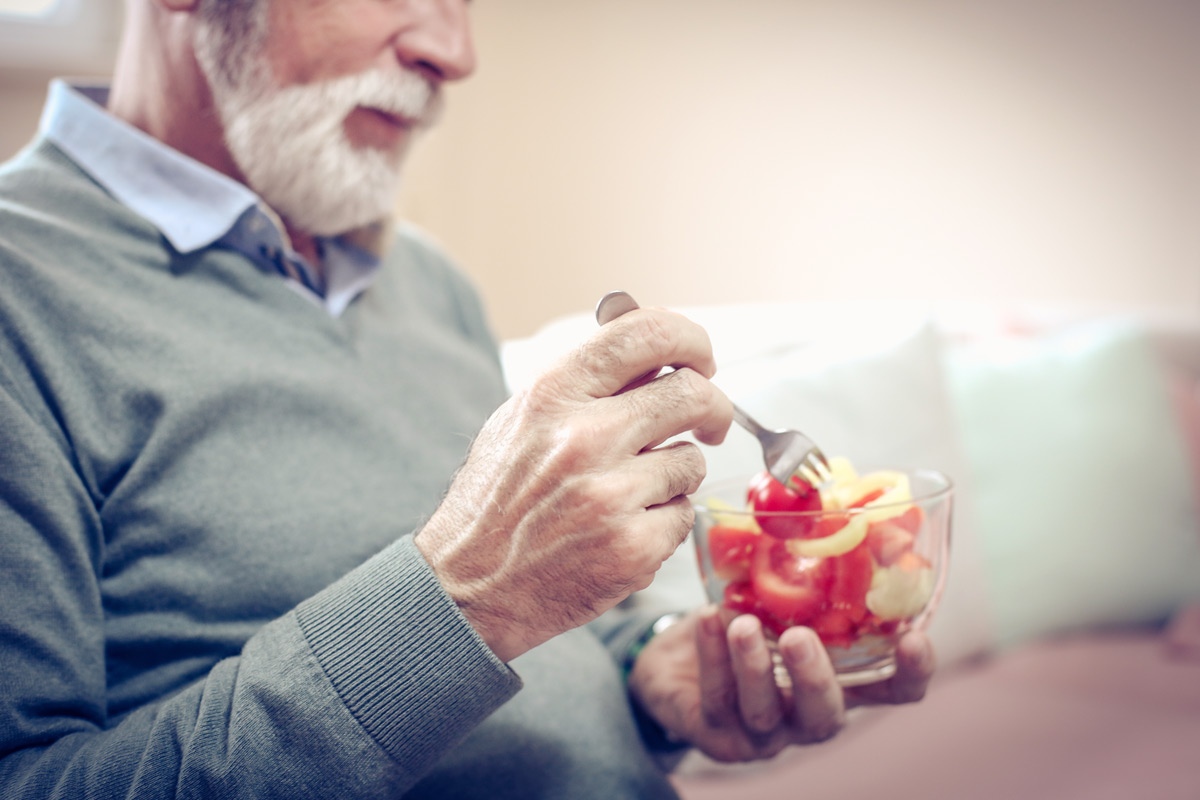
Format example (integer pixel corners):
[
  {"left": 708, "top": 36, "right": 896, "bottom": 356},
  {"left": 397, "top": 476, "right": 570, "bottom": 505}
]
[{"left": 676, "top": 633, "right": 1200, "bottom": 800}]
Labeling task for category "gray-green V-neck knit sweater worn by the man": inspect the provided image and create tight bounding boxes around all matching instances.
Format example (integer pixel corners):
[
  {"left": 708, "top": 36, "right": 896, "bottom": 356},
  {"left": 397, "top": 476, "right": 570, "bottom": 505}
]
[{"left": 0, "top": 140, "right": 673, "bottom": 800}]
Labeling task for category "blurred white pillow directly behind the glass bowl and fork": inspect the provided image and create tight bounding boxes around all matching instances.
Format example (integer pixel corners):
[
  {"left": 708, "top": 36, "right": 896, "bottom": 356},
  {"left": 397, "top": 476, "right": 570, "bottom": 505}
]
[{"left": 503, "top": 302, "right": 992, "bottom": 666}]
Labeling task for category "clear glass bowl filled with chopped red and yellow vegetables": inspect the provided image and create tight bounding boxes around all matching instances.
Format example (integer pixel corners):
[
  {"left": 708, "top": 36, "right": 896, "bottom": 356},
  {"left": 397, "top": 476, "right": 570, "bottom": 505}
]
[{"left": 692, "top": 469, "right": 954, "bottom": 686}]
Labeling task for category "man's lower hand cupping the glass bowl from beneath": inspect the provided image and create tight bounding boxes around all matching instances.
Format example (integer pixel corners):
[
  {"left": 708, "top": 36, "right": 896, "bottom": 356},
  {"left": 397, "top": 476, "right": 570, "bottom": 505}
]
[{"left": 629, "top": 607, "right": 934, "bottom": 762}]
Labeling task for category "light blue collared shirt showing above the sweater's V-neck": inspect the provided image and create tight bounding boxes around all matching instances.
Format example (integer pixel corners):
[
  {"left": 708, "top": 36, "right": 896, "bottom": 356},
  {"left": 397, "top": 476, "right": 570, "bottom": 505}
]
[{"left": 41, "top": 80, "right": 379, "bottom": 317}]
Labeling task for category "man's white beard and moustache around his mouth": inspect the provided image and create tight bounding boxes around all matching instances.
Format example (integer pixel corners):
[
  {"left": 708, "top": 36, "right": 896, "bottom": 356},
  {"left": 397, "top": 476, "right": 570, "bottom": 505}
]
[{"left": 197, "top": 17, "right": 440, "bottom": 236}]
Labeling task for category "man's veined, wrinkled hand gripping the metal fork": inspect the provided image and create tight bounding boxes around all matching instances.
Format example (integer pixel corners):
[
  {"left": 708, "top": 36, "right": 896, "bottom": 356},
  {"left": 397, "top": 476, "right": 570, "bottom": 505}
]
[{"left": 415, "top": 309, "right": 733, "bottom": 661}]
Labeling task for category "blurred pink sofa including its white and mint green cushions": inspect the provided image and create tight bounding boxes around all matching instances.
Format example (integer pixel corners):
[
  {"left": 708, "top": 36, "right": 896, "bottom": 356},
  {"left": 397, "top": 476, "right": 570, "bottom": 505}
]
[{"left": 502, "top": 297, "right": 1200, "bottom": 800}]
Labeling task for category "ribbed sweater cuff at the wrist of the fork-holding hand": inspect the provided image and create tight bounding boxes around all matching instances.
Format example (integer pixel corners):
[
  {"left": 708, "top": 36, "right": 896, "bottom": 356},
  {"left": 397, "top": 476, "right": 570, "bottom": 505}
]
[{"left": 296, "top": 536, "right": 521, "bottom": 772}]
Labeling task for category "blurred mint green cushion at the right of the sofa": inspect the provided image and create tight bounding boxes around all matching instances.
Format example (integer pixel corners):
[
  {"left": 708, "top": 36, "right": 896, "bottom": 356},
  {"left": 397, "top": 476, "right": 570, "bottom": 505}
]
[{"left": 947, "top": 324, "right": 1200, "bottom": 646}]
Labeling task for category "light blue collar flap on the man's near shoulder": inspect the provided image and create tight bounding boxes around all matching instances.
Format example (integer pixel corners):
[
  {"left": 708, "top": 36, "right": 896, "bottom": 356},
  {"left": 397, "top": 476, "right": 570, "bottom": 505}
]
[{"left": 41, "top": 80, "right": 259, "bottom": 253}]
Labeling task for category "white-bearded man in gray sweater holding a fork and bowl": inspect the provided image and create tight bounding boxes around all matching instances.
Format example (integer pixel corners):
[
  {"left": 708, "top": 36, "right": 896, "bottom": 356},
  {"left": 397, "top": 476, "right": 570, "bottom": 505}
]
[{"left": 0, "top": 0, "right": 932, "bottom": 800}]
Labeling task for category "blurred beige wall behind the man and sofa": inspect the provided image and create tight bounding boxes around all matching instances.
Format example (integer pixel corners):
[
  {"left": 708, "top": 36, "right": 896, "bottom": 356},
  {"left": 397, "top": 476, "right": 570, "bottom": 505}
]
[{"left": 0, "top": 0, "right": 1200, "bottom": 337}]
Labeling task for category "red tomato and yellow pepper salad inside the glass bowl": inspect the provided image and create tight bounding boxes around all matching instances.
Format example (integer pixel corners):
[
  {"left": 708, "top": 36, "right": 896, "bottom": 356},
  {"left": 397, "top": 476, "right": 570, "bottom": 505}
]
[{"left": 704, "top": 458, "right": 936, "bottom": 648}]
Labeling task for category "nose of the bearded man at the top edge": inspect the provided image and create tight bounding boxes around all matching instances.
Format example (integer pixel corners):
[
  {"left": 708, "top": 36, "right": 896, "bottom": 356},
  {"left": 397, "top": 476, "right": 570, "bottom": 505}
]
[{"left": 395, "top": 0, "right": 475, "bottom": 80}]
